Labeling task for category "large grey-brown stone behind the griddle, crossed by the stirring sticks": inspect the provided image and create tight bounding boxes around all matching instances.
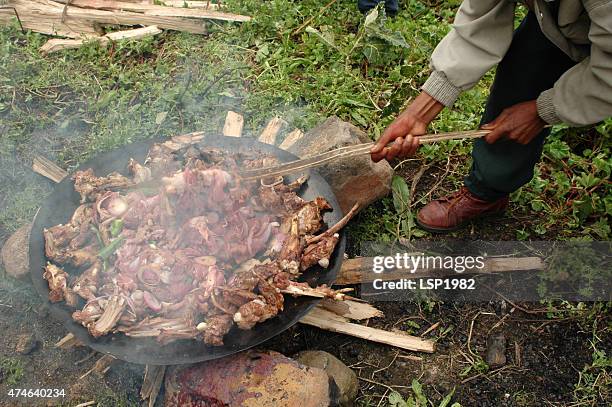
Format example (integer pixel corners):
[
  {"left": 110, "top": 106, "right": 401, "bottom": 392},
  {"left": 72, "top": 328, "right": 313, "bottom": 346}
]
[{"left": 289, "top": 116, "right": 393, "bottom": 213}]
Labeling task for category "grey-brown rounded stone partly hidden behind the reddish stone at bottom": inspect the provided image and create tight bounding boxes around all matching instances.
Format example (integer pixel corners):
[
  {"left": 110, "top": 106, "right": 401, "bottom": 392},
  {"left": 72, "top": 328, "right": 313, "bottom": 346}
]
[{"left": 294, "top": 350, "right": 359, "bottom": 406}]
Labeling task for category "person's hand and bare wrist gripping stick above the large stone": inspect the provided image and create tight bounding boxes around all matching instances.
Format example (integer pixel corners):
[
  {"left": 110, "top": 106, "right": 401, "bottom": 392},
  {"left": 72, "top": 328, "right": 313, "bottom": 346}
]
[{"left": 370, "top": 92, "right": 444, "bottom": 162}]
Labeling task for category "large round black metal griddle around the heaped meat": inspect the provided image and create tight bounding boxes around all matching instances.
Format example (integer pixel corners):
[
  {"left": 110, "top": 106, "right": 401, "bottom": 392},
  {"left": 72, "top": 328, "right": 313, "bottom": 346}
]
[{"left": 30, "top": 136, "right": 346, "bottom": 365}]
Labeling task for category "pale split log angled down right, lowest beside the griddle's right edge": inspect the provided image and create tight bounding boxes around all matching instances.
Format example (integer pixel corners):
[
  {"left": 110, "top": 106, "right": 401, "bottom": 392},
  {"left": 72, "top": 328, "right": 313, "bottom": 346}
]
[{"left": 300, "top": 307, "right": 435, "bottom": 353}]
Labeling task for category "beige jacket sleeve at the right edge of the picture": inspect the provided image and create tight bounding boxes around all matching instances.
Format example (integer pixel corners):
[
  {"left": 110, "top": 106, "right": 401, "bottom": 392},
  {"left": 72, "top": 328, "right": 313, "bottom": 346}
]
[{"left": 537, "top": 0, "right": 612, "bottom": 126}]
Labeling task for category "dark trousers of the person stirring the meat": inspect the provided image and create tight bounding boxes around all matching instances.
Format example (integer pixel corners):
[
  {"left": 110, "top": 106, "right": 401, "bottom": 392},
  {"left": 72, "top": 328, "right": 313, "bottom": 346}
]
[{"left": 465, "top": 12, "right": 576, "bottom": 201}]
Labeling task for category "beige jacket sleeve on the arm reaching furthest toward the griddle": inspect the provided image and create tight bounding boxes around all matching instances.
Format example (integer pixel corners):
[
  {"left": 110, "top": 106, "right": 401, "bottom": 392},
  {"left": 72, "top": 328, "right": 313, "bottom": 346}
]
[{"left": 422, "top": 0, "right": 515, "bottom": 106}]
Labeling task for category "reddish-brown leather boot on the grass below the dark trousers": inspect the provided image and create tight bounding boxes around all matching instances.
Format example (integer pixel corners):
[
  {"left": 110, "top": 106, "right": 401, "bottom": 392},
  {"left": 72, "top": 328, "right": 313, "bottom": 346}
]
[{"left": 417, "top": 187, "right": 508, "bottom": 232}]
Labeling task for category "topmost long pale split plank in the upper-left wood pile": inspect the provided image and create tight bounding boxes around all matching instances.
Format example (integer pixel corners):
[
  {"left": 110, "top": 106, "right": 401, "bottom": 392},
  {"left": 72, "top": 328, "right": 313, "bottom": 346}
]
[{"left": 55, "top": 0, "right": 251, "bottom": 22}]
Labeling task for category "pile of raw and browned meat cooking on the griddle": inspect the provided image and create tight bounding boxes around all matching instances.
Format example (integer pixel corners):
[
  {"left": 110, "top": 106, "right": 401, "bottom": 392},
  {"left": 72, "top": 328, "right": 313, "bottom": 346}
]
[{"left": 43, "top": 142, "right": 348, "bottom": 345}]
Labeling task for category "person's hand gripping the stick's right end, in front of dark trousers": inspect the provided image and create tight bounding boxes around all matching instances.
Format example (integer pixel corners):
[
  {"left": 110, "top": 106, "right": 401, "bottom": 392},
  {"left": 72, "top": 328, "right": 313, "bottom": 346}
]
[{"left": 482, "top": 100, "right": 546, "bottom": 144}]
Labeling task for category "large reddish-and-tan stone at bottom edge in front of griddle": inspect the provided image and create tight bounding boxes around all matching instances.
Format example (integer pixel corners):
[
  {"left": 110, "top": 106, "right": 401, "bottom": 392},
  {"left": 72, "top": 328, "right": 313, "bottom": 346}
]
[{"left": 165, "top": 351, "right": 338, "bottom": 407}]
